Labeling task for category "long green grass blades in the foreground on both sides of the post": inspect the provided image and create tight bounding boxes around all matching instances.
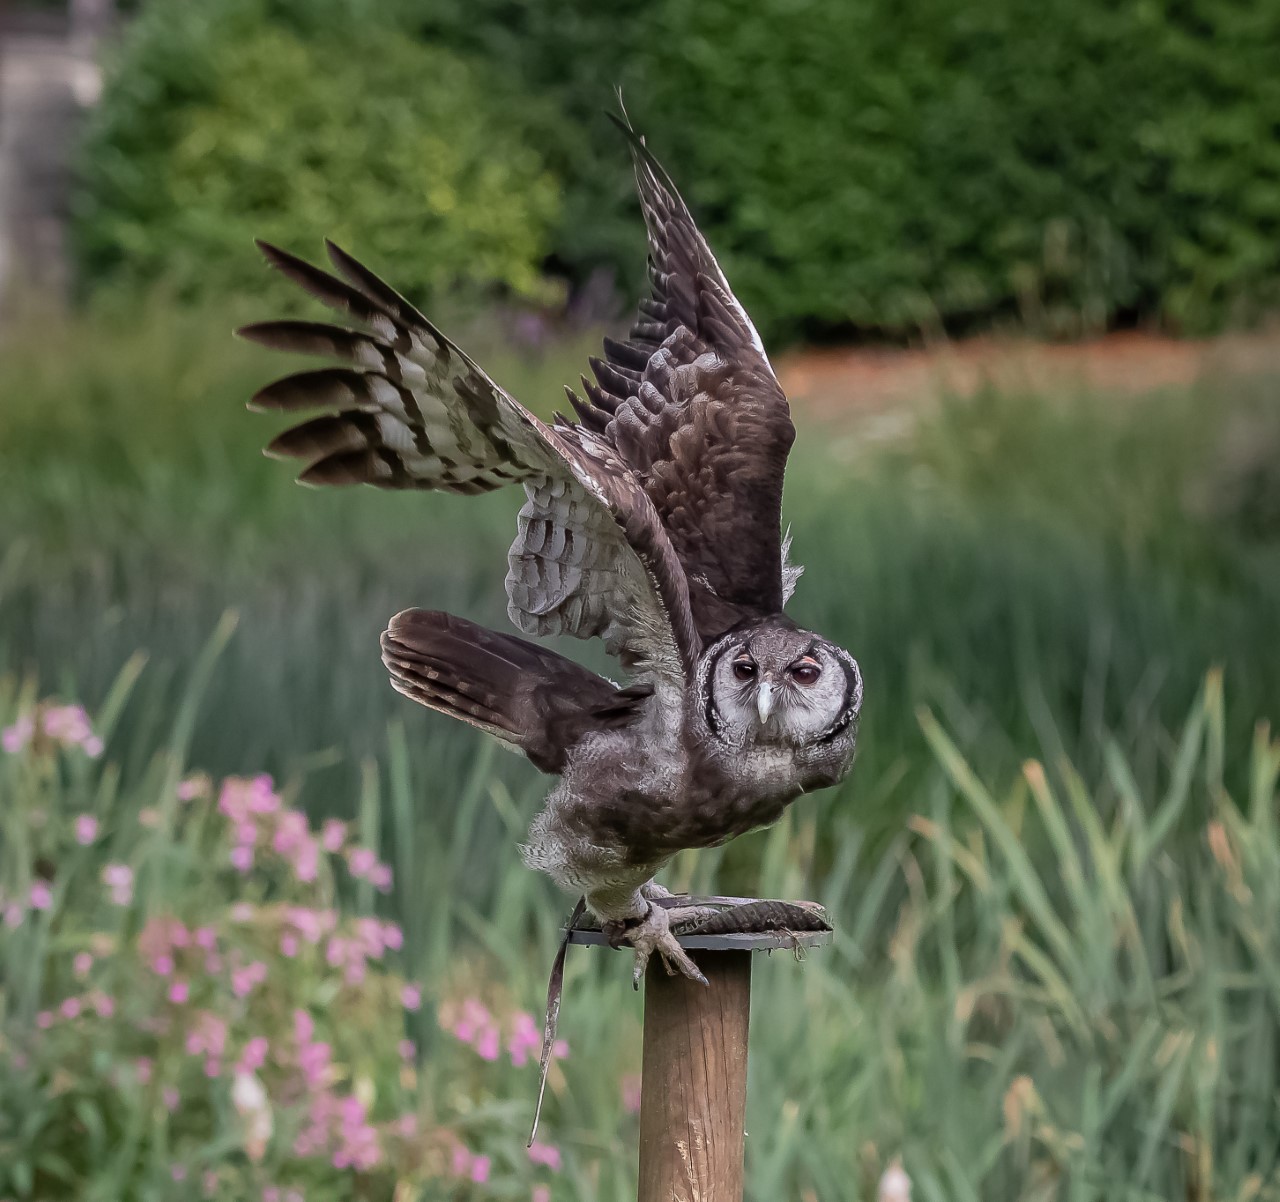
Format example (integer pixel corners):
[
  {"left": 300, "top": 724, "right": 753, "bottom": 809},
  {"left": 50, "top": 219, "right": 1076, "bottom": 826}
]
[{"left": 0, "top": 640, "right": 1280, "bottom": 1202}]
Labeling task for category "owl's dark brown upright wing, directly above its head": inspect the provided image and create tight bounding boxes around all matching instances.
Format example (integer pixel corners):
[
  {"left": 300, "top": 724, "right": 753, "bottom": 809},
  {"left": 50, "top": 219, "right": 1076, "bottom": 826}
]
[{"left": 570, "top": 120, "right": 799, "bottom": 641}]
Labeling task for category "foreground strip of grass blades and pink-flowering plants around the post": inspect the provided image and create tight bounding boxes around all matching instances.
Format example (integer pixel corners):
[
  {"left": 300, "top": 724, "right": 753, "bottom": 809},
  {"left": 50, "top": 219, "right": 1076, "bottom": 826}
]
[{"left": 0, "top": 640, "right": 1280, "bottom": 1202}]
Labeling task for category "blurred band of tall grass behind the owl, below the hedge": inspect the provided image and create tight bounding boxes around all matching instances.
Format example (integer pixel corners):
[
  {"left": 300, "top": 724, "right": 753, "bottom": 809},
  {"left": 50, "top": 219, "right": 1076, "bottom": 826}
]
[{"left": 0, "top": 303, "right": 1280, "bottom": 832}]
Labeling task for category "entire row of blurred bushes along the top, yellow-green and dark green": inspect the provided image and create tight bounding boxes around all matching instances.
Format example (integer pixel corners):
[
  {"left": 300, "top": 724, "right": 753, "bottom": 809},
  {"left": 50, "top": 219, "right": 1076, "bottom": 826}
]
[{"left": 79, "top": 0, "right": 1280, "bottom": 337}]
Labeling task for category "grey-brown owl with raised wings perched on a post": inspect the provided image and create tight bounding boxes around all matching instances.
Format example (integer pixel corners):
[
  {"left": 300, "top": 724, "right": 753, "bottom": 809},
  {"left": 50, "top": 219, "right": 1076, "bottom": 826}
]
[{"left": 238, "top": 119, "right": 863, "bottom": 981}]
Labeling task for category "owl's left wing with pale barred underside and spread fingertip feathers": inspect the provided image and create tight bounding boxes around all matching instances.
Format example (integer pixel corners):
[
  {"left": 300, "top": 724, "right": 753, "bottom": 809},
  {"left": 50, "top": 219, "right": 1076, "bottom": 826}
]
[{"left": 239, "top": 243, "right": 701, "bottom": 682}]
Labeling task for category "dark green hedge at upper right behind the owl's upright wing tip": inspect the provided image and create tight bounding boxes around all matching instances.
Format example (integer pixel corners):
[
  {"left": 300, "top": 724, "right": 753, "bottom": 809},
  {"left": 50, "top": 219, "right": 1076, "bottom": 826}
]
[{"left": 419, "top": 0, "right": 1280, "bottom": 335}]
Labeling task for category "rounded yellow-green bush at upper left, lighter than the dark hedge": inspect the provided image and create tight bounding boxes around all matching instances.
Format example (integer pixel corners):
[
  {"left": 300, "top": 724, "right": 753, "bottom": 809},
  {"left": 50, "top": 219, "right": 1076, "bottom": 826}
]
[{"left": 77, "top": 0, "right": 558, "bottom": 300}]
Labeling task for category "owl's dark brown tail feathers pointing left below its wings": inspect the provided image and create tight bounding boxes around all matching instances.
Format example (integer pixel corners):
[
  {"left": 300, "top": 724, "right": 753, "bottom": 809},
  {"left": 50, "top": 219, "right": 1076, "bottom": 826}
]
[{"left": 381, "top": 609, "right": 648, "bottom": 773}]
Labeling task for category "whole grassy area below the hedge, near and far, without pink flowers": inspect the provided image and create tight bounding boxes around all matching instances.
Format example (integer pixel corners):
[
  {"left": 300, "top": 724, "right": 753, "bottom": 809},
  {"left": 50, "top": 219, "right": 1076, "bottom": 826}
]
[{"left": 0, "top": 295, "right": 1280, "bottom": 1202}]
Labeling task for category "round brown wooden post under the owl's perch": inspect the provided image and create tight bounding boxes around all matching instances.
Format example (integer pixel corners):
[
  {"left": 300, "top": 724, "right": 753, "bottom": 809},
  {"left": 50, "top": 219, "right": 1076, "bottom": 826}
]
[{"left": 639, "top": 951, "right": 751, "bottom": 1202}]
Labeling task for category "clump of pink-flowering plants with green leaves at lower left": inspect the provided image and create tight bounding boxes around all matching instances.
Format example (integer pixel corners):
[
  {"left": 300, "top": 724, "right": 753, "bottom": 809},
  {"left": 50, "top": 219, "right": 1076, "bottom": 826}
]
[{"left": 0, "top": 660, "right": 567, "bottom": 1202}]
